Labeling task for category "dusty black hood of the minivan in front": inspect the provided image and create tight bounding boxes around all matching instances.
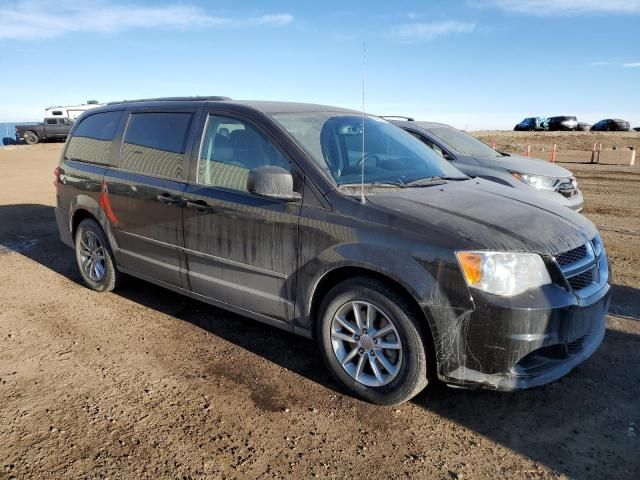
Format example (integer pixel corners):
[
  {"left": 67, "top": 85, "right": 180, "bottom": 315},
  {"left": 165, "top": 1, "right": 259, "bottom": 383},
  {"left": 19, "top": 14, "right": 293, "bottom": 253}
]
[{"left": 367, "top": 179, "right": 597, "bottom": 255}]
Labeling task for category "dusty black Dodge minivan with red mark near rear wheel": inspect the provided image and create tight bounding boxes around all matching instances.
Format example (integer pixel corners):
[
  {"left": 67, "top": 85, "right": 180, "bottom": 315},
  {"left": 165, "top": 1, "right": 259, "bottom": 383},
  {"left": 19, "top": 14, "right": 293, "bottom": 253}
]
[{"left": 55, "top": 97, "right": 610, "bottom": 404}]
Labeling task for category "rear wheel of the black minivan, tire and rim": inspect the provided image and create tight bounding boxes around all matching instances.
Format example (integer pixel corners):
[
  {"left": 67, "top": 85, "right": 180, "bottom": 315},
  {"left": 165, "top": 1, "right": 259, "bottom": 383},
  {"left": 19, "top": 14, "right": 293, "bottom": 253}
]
[{"left": 74, "top": 219, "right": 120, "bottom": 292}]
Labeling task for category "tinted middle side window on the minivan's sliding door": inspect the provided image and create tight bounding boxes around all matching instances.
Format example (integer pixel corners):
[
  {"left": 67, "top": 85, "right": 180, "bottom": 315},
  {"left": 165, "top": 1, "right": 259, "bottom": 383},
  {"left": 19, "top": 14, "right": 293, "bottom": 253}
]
[{"left": 120, "top": 112, "right": 193, "bottom": 179}]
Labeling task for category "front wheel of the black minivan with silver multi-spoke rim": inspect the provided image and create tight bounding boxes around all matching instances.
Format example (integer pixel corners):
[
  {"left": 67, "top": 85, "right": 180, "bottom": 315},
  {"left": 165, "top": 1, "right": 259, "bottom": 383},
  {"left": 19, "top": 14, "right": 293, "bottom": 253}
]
[{"left": 316, "top": 277, "right": 432, "bottom": 405}]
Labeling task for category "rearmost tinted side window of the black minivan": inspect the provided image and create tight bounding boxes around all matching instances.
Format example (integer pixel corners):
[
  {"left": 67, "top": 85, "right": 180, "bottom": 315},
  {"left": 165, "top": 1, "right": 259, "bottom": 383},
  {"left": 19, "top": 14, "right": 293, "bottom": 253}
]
[{"left": 66, "top": 111, "right": 122, "bottom": 165}]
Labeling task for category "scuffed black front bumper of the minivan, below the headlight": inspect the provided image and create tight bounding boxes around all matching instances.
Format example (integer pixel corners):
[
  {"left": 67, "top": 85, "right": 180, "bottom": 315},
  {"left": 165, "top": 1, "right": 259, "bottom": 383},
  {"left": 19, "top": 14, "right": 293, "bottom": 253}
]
[{"left": 440, "top": 284, "right": 610, "bottom": 391}]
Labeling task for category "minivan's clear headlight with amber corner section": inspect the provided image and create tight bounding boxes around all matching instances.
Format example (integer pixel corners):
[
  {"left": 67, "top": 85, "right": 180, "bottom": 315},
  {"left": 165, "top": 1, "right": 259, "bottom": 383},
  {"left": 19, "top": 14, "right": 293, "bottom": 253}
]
[{"left": 456, "top": 252, "right": 551, "bottom": 297}]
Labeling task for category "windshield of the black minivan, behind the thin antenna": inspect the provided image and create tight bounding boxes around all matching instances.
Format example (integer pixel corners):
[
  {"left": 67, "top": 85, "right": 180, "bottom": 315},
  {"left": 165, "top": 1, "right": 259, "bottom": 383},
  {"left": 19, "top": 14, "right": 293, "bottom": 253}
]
[{"left": 272, "top": 112, "right": 466, "bottom": 185}]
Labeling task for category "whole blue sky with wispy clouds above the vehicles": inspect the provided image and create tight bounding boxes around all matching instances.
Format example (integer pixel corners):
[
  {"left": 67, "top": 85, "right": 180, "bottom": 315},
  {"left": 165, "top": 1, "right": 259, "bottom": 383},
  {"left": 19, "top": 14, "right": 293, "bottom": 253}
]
[{"left": 0, "top": 0, "right": 640, "bottom": 130}]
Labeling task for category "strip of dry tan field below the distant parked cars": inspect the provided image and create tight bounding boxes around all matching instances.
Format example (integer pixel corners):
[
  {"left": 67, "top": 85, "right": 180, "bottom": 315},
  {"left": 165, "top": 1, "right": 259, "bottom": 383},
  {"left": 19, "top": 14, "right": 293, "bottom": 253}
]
[{"left": 469, "top": 130, "right": 640, "bottom": 152}]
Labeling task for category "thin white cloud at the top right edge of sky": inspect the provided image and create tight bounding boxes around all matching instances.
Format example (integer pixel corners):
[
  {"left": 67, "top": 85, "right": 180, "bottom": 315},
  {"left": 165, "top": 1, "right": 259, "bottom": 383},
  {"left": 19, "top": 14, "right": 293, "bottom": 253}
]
[{"left": 482, "top": 0, "right": 640, "bottom": 15}]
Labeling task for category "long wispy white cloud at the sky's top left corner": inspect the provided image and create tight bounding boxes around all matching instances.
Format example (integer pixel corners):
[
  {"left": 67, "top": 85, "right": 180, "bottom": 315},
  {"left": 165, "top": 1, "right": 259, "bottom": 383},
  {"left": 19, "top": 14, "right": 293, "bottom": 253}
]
[{"left": 0, "top": 0, "right": 293, "bottom": 39}]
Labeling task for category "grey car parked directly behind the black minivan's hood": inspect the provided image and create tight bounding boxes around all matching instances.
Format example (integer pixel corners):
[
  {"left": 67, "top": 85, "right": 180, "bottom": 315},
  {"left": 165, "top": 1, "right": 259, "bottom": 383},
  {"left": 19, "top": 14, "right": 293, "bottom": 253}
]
[{"left": 384, "top": 119, "right": 584, "bottom": 212}]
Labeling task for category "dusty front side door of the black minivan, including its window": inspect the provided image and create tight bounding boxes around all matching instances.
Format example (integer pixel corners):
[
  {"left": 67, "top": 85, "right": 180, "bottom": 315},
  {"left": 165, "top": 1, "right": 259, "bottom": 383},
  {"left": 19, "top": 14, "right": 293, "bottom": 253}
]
[{"left": 184, "top": 111, "right": 302, "bottom": 323}]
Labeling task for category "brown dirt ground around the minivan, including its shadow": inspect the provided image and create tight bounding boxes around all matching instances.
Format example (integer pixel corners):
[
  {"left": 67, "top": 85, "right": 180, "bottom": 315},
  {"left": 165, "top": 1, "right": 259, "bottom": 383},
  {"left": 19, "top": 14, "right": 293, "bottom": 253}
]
[{"left": 0, "top": 140, "right": 640, "bottom": 479}]
